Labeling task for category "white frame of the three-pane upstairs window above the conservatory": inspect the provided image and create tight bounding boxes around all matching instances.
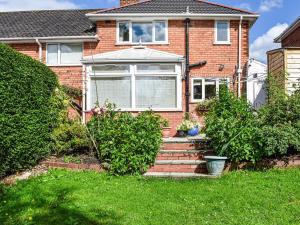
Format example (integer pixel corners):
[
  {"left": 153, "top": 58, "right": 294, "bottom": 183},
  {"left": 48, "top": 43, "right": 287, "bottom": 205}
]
[{"left": 116, "top": 20, "right": 169, "bottom": 45}]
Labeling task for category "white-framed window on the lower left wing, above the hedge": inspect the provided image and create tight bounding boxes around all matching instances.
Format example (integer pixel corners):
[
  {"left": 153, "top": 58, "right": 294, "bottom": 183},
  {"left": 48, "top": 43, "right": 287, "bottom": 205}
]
[{"left": 46, "top": 43, "right": 82, "bottom": 66}]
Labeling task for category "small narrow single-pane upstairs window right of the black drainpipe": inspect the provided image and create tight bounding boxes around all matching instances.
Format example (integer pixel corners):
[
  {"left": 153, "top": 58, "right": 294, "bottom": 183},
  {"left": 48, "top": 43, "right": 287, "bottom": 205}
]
[{"left": 215, "top": 20, "right": 230, "bottom": 44}]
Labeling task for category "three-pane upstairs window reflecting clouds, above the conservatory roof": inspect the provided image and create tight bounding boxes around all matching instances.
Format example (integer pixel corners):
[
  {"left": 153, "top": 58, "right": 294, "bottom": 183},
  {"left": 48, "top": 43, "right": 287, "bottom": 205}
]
[{"left": 117, "top": 21, "right": 168, "bottom": 44}]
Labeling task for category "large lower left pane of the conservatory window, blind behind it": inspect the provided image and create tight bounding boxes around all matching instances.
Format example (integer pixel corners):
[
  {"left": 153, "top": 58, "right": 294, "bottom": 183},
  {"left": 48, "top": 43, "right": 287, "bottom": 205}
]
[{"left": 91, "top": 77, "right": 131, "bottom": 108}]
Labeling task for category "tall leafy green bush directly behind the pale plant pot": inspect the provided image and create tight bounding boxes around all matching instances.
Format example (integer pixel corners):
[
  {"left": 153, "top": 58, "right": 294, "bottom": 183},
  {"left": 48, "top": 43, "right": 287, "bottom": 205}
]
[{"left": 206, "top": 88, "right": 261, "bottom": 162}]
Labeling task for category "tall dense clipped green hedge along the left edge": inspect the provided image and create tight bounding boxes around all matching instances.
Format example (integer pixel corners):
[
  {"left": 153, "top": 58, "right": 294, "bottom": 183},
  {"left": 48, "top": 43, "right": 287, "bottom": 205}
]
[{"left": 0, "top": 44, "right": 60, "bottom": 177}]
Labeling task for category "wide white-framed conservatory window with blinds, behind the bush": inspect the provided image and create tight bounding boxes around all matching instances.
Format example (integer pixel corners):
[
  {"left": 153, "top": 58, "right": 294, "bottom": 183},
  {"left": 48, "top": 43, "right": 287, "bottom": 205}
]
[{"left": 88, "top": 63, "right": 181, "bottom": 111}]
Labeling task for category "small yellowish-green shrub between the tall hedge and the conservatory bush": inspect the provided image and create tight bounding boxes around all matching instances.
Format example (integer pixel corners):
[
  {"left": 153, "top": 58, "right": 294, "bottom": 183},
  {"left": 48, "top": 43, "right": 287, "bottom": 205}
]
[{"left": 52, "top": 120, "right": 92, "bottom": 156}]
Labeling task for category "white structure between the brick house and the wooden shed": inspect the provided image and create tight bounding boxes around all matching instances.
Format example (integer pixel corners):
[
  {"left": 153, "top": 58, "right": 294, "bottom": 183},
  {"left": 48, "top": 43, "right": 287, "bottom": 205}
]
[{"left": 247, "top": 59, "right": 267, "bottom": 109}]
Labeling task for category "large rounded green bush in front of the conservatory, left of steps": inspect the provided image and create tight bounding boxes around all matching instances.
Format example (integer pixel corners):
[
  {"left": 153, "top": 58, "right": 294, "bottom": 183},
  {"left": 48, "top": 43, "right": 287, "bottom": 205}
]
[{"left": 88, "top": 104, "right": 162, "bottom": 175}]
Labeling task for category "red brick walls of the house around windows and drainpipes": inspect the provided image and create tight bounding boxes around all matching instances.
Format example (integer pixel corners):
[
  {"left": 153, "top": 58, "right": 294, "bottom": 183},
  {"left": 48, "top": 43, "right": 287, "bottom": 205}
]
[{"left": 8, "top": 20, "right": 249, "bottom": 134}]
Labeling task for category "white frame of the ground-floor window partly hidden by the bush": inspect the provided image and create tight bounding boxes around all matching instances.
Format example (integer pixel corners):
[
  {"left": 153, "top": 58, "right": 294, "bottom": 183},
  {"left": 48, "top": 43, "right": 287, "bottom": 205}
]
[{"left": 191, "top": 77, "right": 230, "bottom": 103}]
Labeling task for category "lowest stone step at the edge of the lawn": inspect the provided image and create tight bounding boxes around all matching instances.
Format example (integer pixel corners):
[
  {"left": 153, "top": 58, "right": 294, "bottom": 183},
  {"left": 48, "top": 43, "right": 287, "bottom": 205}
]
[{"left": 144, "top": 172, "right": 218, "bottom": 178}]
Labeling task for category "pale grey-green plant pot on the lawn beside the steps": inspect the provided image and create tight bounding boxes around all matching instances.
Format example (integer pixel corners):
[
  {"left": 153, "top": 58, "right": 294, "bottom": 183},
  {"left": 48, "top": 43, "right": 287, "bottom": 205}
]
[{"left": 204, "top": 156, "right": 227, "bottom": 176}]
